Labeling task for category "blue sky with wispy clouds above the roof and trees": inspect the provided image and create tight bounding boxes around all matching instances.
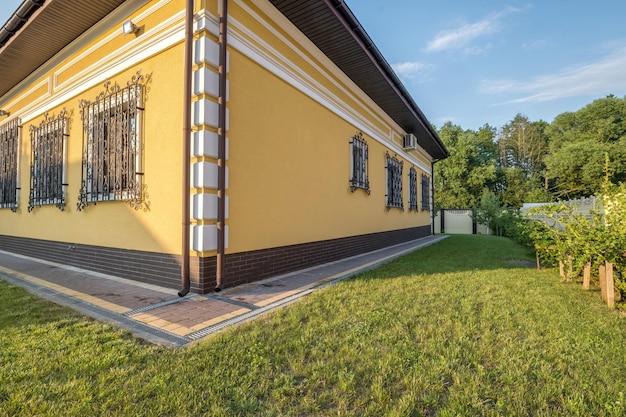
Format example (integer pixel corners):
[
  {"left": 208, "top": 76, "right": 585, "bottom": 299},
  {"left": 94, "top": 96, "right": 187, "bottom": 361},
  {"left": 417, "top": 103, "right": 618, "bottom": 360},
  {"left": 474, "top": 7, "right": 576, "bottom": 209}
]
[{"left": 0, "top": 0, "right": 626, "bottom": 130}]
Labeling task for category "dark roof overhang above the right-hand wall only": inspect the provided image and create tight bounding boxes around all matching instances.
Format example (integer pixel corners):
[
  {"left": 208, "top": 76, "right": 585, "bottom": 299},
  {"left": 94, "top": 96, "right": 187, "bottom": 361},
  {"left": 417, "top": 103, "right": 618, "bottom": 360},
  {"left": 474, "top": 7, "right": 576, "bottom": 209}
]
[{"left": 270, "top": 0, "right": 449, "bottom": 160}]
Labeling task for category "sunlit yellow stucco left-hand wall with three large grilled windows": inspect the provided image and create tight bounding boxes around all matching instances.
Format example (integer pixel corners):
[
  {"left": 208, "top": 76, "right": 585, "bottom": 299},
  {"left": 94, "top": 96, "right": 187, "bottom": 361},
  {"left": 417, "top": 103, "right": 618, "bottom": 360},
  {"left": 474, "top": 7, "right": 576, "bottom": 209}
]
[{"left": 0, "top": 1, "right": 184, "bottom": 253}]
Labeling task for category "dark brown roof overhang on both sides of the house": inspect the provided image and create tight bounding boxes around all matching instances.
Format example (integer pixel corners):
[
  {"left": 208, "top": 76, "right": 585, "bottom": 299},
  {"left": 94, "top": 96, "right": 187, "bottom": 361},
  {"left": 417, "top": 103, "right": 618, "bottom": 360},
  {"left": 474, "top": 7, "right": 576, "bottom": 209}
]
[{"left": 0, "top": 0, "right": 449, "bottom": 160}]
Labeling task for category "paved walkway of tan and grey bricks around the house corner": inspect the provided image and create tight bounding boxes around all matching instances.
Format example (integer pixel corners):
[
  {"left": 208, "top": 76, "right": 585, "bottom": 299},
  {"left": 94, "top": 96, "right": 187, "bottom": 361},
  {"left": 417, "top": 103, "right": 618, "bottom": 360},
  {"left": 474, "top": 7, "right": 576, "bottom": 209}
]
[{"left": 0, "top": 235, "right": 446, "bottom": 346}]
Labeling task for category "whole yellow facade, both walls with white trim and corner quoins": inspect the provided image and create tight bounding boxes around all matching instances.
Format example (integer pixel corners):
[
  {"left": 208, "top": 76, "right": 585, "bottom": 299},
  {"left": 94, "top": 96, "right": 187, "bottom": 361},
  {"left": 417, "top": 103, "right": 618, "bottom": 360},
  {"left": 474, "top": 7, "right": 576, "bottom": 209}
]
[{"left": 0, "top": 0, "right": 442, "bottom": 288}]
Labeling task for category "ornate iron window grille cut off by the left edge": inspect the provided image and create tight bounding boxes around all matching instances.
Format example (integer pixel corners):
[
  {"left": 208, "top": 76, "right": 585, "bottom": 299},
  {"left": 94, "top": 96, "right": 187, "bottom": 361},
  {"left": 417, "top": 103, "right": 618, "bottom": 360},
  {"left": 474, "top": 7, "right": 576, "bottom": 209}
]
[{"left": 0, "top": 118, "right": 21, "bottom": 212}]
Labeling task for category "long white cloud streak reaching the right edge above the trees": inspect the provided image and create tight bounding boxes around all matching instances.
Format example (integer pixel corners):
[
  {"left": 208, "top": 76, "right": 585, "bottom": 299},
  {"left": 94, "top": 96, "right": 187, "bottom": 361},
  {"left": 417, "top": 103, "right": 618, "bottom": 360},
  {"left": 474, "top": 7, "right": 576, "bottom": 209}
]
[{"left": 480, "top": 46, "right": 626, "bottom": 104}]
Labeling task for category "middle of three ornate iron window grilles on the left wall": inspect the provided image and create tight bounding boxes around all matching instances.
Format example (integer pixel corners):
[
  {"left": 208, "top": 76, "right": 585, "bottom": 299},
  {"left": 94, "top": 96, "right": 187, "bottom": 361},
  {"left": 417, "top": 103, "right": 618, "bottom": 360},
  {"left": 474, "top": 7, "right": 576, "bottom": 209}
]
[{"left": 28, "top": 110, "right": 69, "bottom": 212}]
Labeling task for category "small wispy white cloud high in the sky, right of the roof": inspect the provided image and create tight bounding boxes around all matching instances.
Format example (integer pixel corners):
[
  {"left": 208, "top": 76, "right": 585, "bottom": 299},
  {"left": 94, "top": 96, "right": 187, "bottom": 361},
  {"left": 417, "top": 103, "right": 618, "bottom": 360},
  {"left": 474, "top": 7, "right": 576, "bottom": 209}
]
[{"left": 425, "top": 7, "right": 521, "bottom": 54}]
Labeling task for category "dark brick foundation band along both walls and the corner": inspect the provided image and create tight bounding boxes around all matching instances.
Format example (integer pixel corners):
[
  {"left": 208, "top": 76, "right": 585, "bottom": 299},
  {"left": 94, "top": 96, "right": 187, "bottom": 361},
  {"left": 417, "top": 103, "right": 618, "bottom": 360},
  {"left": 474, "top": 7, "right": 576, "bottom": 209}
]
[{"left": 0, "top": 225, "right": 431, "bottom": 294}]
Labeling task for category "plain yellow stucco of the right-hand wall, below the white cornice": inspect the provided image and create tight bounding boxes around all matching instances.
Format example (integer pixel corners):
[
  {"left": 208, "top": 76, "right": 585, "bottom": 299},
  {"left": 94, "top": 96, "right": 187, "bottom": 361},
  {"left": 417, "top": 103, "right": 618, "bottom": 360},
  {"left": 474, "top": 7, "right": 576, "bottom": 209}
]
[{"left": 228, "top": 48, "right": 430, "bottom": 252}]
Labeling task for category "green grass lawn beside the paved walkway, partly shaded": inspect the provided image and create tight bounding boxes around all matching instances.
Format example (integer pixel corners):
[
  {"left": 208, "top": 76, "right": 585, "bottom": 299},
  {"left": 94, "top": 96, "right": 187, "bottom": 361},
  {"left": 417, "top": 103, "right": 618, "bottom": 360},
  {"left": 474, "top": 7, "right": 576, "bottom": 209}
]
[{"left": 0, "top": 236, "right": 626, "bottom": 416}]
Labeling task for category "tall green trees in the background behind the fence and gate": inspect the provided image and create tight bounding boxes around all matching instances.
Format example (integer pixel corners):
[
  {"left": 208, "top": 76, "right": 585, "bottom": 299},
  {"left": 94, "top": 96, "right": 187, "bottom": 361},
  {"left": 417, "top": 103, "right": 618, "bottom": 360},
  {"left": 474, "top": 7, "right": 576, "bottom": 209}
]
[{"left": 434, "top": 95, "right": 626, "bottom": 208}]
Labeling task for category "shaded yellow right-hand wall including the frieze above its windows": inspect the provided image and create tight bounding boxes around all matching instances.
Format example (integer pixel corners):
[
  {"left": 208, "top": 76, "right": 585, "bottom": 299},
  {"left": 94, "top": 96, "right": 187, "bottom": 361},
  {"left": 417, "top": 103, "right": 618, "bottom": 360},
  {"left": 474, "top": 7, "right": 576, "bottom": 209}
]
[{"left": 228, "top": 1, "right": 430, "bottom": 253}]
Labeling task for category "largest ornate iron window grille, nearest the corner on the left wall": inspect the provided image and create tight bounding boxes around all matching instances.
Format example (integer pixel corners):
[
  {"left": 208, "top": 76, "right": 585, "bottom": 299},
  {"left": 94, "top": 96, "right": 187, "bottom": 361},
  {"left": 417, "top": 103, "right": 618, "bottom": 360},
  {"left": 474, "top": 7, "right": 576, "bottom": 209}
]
[{"left": 77, "top": 72, "right": 144, "bottom": 211}]
